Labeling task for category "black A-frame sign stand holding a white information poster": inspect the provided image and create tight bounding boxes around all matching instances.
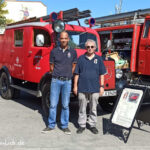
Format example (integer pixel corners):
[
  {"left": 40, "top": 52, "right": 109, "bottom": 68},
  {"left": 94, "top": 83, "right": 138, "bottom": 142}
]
[{"left": 103, "top": 86, "right": 147, "bottom": 143}]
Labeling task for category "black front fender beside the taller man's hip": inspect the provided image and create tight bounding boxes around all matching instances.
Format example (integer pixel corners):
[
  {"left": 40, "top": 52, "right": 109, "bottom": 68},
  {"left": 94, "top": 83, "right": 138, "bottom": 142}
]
[{"left": 38, "top": 72, "right": 52, "bottom": 91}]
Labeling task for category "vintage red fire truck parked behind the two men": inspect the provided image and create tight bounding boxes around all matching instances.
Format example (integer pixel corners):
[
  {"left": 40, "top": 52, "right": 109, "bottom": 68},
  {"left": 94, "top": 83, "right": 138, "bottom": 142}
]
[{"left": 0, "top": 8, "right": 115, "bottom": 114}]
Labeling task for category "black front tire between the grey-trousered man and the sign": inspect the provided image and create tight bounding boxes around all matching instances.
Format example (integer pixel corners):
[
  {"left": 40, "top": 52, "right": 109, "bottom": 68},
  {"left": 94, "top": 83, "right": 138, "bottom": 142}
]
[{"left": 99, "top": 97, "right": 116, "bottom": 113}]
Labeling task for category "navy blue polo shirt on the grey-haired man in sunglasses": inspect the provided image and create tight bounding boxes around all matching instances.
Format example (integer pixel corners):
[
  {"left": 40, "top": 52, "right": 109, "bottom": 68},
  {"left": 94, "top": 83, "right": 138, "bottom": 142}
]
[{"left": 75, "top": 54, "right": 106, "bottom": 93}]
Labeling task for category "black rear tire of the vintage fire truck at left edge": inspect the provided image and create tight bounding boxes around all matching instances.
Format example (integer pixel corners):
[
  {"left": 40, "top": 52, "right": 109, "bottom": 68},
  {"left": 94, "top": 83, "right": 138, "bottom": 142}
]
[{"left": 0, "top": 72, "right": 14, "bottom": 100}]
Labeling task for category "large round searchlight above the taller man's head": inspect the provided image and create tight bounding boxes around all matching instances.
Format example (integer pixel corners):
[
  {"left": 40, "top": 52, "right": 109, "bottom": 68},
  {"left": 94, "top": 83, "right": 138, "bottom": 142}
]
[{"left": 53, "top": 20, "right": 65, "bottom": 33}]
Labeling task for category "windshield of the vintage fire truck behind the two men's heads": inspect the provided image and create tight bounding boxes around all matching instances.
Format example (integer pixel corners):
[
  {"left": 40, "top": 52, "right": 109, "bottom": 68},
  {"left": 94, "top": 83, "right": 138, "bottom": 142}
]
[{"left": 58, "top": 31, "right": 98, "bottom": 51}]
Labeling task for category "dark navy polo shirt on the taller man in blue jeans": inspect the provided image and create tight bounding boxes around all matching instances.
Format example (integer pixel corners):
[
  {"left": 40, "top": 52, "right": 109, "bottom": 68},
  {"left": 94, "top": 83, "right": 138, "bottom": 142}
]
[{"left": 50, "top": 47, "right": 77, "bottom": 79}]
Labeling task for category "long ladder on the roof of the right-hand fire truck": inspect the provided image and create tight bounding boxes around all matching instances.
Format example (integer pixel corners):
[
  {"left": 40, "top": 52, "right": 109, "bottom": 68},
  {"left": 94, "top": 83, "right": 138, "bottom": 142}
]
[{"left": 85, "top": 8, "right": 150, "bottom": 25}]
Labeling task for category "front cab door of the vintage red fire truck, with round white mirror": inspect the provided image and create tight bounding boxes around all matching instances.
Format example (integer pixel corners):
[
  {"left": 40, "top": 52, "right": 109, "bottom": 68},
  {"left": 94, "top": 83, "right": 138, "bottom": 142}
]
[{"left": 24, "top": 27, "right": 54, "bottom": 83}]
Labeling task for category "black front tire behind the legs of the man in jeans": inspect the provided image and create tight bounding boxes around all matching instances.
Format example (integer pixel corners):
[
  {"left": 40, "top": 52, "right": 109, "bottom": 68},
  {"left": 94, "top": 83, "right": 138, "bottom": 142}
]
[{"left": 42, "top": 83, "right": 61, "bottom": 122}]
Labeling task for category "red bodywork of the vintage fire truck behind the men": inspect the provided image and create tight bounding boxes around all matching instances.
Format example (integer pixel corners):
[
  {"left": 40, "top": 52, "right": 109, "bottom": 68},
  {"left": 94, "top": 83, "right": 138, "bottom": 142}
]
[{"left": 0, "top": 24, "right": 112, "bottom": 86}]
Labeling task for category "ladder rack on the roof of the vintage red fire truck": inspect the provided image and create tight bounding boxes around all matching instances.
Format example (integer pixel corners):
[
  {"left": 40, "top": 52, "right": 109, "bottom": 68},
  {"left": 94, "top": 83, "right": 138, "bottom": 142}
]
[{"left": 7, "top": 8, "right": 91, "bottom": 26}]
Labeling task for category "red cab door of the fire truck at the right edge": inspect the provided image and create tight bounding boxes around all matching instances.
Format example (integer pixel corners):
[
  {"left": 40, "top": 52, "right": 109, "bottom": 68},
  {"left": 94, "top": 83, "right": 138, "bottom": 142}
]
[{"left": 138, "top": 20, "right": 150, "bottom": 75}]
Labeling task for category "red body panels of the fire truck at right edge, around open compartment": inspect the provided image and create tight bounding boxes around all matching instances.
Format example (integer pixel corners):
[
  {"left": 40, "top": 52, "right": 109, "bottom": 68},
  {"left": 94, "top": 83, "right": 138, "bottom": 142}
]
[{"left": 96, "top": 16, "right": 150, "bottom": 81}]
